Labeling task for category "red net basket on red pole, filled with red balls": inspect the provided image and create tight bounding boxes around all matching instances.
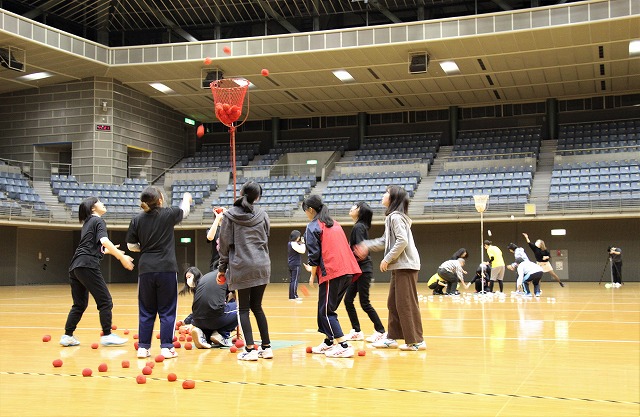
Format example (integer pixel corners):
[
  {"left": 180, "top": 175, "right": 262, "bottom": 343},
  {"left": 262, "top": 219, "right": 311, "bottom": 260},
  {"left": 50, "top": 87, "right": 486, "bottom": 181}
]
[{"left": 210, "top": 78, "right": 249, "bottom": 200}]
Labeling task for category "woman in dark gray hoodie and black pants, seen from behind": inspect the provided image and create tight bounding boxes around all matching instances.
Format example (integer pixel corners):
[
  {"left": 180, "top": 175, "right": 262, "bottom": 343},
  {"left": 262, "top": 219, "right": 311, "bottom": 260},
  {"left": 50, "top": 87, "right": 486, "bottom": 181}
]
[{"left": 217, "top": 181, "right": 273, "bottom": 361}]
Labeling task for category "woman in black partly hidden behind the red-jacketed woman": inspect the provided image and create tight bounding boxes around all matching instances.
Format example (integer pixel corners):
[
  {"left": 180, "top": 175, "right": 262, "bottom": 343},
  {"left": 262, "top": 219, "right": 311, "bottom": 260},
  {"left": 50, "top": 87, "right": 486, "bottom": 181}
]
[{"left": 344, "top": 201, "right": 386, "bottom": 343}]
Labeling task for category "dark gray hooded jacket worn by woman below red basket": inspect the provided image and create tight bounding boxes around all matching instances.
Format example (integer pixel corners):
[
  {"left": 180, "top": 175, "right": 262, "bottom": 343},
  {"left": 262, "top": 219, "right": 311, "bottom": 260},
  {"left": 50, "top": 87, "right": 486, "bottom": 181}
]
[{"left": 218, "top": 202, "right": 271, "bottom": 290}]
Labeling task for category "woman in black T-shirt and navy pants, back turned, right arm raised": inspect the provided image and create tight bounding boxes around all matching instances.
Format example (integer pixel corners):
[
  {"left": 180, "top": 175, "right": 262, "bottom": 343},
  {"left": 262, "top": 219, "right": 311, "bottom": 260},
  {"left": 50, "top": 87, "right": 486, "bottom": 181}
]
[{"left": 127, "top": 186, "right": 192, "bottom": 359}]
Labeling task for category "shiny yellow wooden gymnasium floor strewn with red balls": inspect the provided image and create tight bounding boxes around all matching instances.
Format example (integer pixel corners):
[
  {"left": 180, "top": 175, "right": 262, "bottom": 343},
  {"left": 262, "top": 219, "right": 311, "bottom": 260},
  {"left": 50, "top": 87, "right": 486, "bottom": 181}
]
[{"left": 0, "top": 282, "right": 640, "bottom": 416}]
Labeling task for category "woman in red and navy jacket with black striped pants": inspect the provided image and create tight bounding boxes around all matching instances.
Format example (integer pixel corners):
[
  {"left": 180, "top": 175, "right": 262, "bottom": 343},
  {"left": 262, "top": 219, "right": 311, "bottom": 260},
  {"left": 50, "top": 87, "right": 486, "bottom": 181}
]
[{"left": 302, "top": 195, "right": 361, "bottom": 358}]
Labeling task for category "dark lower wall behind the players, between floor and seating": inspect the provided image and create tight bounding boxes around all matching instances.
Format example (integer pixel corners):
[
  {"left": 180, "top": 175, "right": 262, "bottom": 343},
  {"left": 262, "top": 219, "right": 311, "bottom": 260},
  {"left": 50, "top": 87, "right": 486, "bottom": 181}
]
[{"left": 0, "top": 218, "right": 640, "bottom": 288}]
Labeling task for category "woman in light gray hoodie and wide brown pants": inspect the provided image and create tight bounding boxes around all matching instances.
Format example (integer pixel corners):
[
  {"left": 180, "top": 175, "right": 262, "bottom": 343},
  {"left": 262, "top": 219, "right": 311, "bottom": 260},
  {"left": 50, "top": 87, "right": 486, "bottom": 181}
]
[{"left": 355, "top": 185, "right": 427, "bottom": 351}]
